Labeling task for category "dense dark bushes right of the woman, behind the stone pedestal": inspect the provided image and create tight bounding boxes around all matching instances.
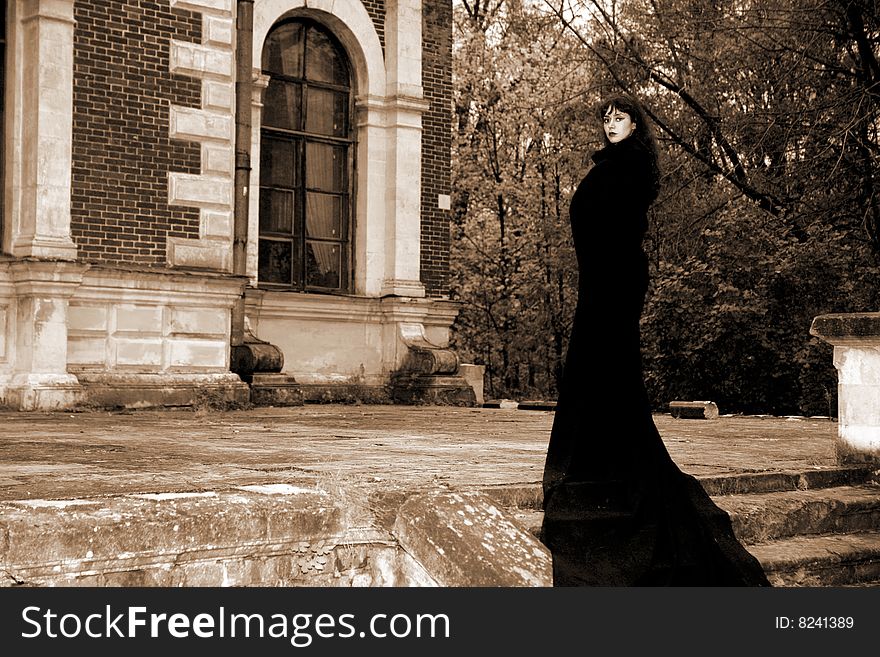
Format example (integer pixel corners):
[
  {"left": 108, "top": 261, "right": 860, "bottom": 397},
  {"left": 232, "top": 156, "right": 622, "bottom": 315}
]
[{"left": 642, "top": 201, "right": 880, "bottom": 415}]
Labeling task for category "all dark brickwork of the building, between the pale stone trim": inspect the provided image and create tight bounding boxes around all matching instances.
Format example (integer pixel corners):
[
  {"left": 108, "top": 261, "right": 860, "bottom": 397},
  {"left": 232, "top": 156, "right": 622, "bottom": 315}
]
[{"left": 71, "top": 0, "right": 452, "bottom": 296}]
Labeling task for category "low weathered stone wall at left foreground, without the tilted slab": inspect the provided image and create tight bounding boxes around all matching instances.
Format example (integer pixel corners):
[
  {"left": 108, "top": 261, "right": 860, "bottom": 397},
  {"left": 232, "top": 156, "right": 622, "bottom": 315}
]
[{"left": 0, "top": 484, "right": 436, "bottom": 587}]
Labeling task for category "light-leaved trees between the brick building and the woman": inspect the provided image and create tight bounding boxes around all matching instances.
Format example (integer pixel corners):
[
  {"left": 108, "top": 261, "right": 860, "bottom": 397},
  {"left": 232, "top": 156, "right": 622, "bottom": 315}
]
[{"left": 451, "top": 5, "right": 585, "bottom": 396}]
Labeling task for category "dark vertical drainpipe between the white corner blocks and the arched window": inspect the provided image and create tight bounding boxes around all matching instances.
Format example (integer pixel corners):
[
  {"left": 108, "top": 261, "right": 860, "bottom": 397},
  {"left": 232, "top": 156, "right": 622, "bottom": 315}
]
[{"left": 230, "top": 0, "right": 254, "bottom": 347}]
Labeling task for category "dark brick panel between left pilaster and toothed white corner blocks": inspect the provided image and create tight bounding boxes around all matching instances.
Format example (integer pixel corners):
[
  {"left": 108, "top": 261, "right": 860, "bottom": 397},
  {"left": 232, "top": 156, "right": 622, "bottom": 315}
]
[{"left": 71, "top": 0, "right": 202, "bottom": 266}]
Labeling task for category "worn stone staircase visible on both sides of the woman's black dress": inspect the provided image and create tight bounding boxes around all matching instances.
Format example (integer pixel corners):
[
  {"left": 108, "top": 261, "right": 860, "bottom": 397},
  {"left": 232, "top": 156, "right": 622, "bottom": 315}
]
[{"left": 486, "top": 466, "right": 880, "bottom": 587}]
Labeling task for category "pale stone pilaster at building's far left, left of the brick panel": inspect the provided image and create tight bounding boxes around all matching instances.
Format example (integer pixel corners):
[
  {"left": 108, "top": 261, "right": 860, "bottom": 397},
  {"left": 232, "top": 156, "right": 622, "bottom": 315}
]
[{"left": 10, "top": 0, "right": 76, "bottom": 260}]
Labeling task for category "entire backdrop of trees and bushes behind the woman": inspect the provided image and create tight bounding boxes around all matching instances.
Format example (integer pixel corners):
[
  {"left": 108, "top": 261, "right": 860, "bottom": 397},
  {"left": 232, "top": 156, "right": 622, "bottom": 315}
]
[{"left": 453, "top": 0, "right": 880, "bottom": 415}]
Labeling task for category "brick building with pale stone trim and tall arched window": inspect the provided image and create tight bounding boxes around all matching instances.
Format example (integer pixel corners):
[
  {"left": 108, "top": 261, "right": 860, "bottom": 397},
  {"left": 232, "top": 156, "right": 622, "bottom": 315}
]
[{"left": 0, "top": 0, "right": 472, "bottom": 409}]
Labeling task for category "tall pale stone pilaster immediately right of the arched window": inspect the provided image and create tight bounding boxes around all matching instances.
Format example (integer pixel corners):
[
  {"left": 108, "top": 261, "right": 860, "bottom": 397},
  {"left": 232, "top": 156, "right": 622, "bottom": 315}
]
[{"left": 381, "top": 0, "right": 428, "bottom": 297}]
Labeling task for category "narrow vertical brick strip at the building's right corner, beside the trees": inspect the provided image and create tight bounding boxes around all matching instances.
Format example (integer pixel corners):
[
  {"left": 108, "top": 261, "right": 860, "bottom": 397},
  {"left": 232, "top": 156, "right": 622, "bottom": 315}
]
[{"left": 421, "top": 0, "right": 452, "bottom": 296}]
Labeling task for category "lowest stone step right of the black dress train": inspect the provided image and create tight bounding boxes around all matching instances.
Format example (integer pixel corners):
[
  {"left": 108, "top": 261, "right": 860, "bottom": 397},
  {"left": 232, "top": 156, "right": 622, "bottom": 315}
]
[{"left": 746, "top": 531, "right": 880, "bottom": 587}]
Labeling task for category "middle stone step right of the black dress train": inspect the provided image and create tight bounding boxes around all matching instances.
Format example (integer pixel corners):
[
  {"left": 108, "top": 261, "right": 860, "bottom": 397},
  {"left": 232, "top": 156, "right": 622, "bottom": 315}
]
[{"left": 713, "top": 484, "right": 880, "bottom": 545}]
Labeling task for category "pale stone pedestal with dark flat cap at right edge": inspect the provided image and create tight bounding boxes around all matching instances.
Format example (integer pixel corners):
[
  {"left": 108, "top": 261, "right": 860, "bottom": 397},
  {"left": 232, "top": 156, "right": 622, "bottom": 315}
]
[{"left": 810, "top": 313, "right": 880, "bottom": 463}]
